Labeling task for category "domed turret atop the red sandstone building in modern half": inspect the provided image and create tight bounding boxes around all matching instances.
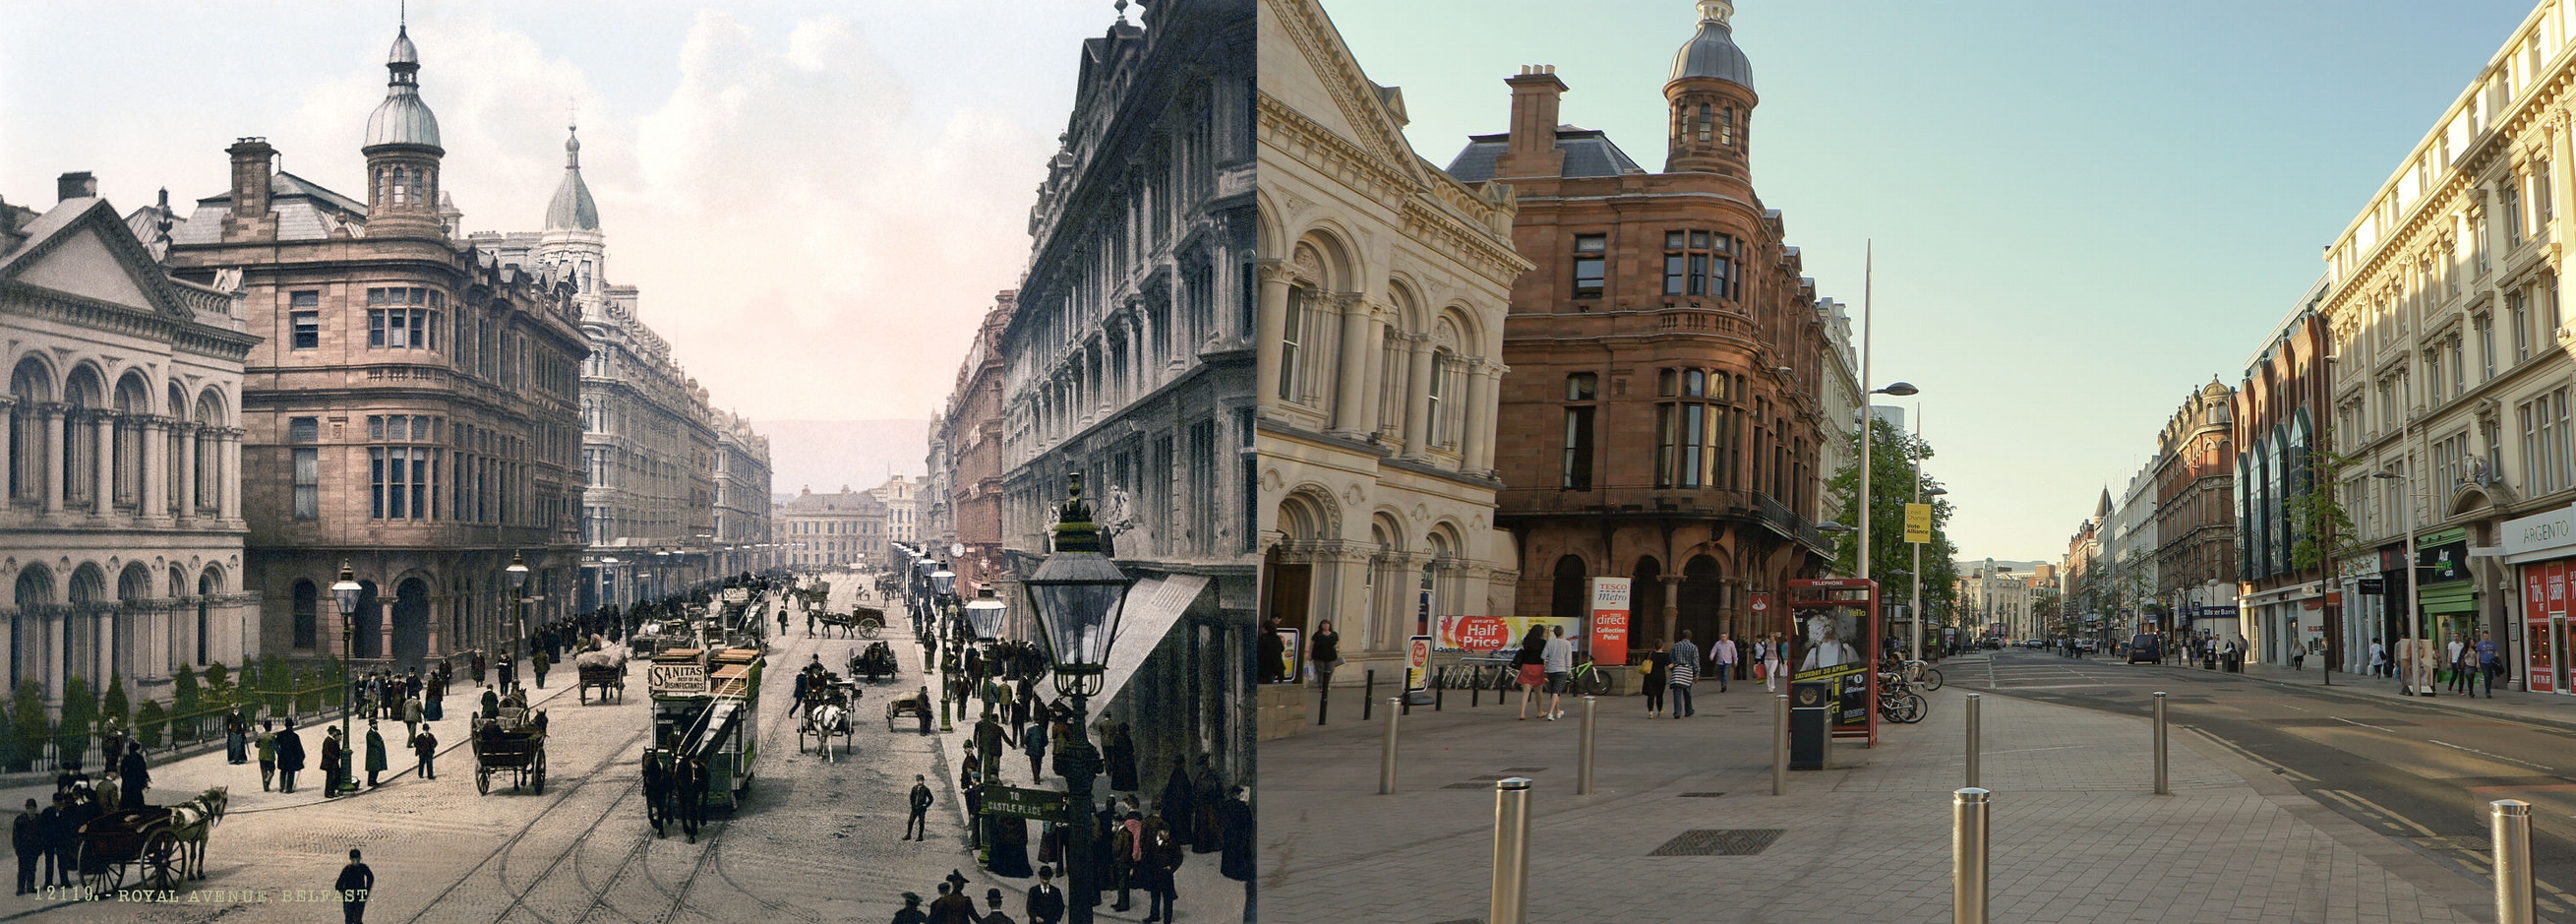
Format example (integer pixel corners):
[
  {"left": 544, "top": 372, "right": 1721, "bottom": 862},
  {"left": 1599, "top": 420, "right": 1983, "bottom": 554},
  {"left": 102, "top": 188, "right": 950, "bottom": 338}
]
[{"left": 1664, "top": 0, "right": 1757, "bottom": 177}]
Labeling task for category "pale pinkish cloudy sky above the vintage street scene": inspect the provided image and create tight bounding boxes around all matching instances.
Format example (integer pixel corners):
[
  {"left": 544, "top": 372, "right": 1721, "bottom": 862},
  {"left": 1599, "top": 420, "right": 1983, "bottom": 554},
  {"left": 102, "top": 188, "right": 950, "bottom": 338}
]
[{"left": 0, "top": 0, "right": 1115, "bottom": 419}]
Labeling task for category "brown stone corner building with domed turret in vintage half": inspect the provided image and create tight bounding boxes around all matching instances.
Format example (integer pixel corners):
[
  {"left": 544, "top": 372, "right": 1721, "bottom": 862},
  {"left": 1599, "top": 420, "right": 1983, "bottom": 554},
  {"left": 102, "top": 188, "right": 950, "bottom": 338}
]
[{"left": 167, "top": 25, "right": 587, "bottom": 666}]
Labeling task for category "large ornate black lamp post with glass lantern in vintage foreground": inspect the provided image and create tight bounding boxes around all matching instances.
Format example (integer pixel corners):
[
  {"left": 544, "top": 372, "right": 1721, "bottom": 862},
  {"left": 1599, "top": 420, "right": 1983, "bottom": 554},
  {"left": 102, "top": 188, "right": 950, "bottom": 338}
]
[{"left": 1020, "top": 471, "right": 1133, "bottom": 924}]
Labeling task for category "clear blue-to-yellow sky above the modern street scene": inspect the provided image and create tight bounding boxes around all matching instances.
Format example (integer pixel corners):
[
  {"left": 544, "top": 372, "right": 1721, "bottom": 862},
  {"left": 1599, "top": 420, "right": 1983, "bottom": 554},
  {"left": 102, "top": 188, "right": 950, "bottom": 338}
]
[{"left": 1324, "top": 0, "right": 2535, "bottom": 561}]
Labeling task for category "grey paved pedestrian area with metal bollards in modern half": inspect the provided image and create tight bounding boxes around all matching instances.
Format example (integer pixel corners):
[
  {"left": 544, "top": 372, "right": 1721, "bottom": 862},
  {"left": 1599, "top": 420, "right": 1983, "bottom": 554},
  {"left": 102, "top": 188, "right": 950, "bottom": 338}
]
[{"left": 1262, "top": 685, "right": 2486, "bottom": 924}]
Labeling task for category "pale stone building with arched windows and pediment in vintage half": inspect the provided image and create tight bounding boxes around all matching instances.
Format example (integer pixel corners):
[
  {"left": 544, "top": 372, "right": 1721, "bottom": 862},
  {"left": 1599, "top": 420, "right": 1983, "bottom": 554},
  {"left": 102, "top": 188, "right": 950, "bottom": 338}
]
[{"left": 0, "top": 182, "right": 261, "bottom": 708}]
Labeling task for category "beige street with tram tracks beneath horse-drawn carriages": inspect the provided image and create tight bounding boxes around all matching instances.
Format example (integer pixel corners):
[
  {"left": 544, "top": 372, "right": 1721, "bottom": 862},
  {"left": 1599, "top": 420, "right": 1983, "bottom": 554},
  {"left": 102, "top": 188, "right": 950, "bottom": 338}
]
[{"left": 0, "top": 574, "right": 1241, "bottom": 924}]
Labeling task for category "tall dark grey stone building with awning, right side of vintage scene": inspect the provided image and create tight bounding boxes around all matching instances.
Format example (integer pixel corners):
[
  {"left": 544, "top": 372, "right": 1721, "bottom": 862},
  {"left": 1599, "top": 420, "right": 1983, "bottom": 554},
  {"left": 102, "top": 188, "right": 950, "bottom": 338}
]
[{"left": 999, "top": 0, "right": 1260, "bottom": 797}]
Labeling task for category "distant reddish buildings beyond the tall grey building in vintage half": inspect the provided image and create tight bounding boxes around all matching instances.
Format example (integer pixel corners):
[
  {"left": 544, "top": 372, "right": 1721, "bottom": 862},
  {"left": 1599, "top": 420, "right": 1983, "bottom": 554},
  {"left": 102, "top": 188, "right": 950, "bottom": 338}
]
[{"left": 923, "top": 288, "right": 1020, "bottom": 604}]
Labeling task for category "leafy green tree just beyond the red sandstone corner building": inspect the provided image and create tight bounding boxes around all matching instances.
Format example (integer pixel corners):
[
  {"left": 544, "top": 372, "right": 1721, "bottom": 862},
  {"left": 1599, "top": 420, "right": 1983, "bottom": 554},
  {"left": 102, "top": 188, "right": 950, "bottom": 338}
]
[{"left": 1827, "top": 414, "right": 1957, "bottom": 630}]
